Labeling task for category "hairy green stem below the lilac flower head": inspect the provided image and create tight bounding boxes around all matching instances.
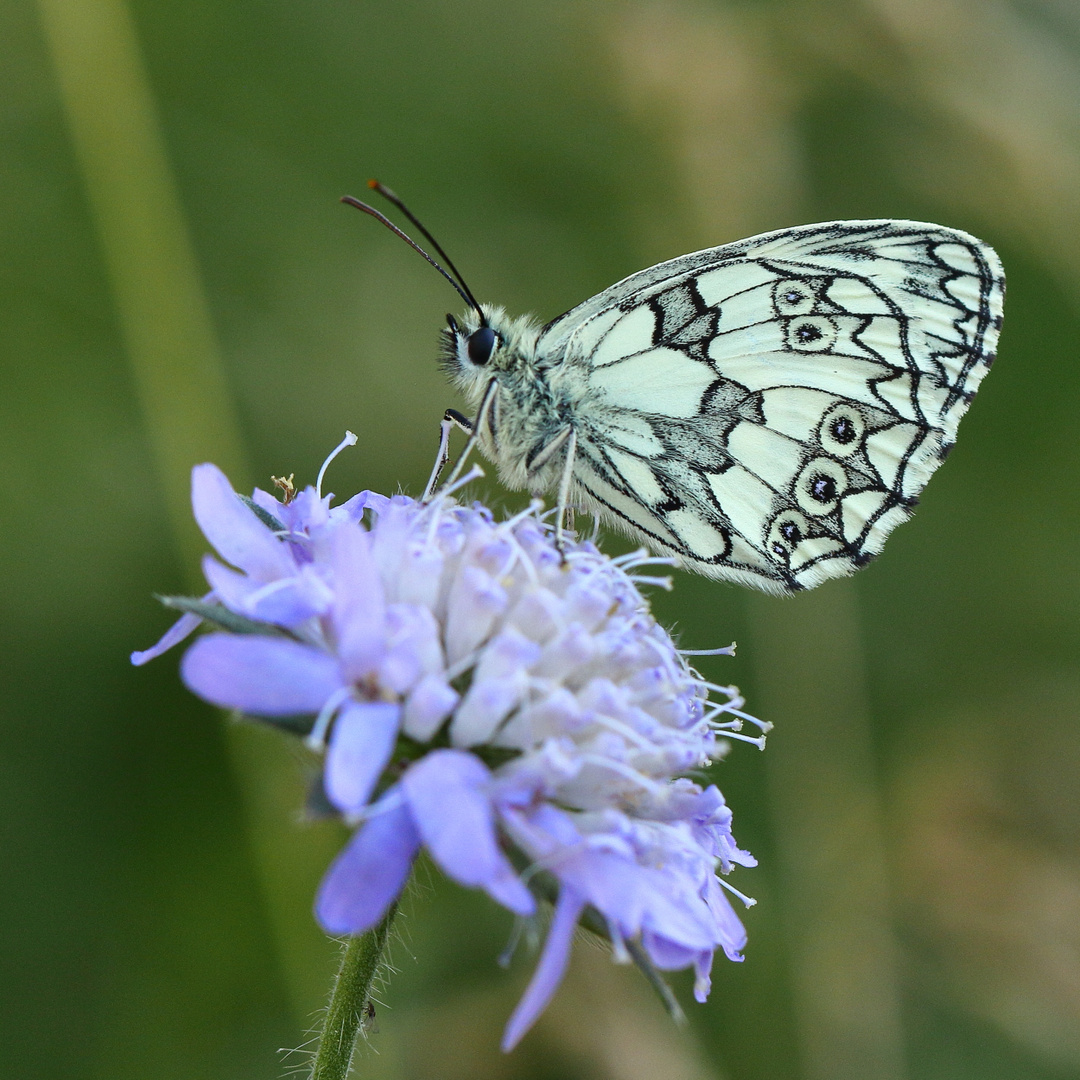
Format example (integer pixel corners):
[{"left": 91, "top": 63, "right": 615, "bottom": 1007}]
[{"left": 311, "top": 904, "right": 397, "bottom": 1080}]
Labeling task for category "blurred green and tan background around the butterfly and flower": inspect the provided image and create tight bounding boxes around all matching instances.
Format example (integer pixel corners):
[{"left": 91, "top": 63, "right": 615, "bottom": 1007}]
[{"left": 0, "top": 0, "right": 1080, "bottom": 1080}]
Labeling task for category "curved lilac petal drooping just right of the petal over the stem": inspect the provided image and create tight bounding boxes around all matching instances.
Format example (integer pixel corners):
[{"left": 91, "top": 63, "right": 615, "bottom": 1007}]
[{"left": 402, "top": 750, "right": 536, "bottom": 915}]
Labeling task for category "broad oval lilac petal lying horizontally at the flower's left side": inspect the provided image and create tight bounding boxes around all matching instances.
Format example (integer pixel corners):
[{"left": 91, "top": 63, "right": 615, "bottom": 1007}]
[{"left": 180, "top": 634, "right": 341, "bottom": 716}]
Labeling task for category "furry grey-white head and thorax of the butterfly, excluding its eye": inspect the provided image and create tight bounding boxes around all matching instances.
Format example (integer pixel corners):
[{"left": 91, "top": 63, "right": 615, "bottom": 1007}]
[{"left": 442, "top": 306, "right": 590, "bottom": 494}]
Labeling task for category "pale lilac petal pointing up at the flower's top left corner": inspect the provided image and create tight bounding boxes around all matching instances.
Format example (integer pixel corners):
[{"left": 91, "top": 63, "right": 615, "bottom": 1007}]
[{"left": 191, "top": 462, "right": 296, "bottom": 581}]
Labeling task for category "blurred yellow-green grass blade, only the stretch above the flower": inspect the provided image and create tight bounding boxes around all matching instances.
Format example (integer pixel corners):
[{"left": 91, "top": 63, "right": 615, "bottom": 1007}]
[{"left": 38, "top": 0, "right": 249, "bottom": 572}]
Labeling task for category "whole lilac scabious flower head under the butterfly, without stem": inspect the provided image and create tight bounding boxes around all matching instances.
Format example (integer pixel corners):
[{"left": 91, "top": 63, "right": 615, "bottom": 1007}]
[{"left": 132, "top": 436, "right": 765, "bottom": 1050}]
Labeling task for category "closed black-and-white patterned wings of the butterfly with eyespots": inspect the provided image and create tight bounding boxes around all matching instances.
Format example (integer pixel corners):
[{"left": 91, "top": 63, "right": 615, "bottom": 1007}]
[{"left": 537, "top": 220, "right": 1004, "bottom": 592}]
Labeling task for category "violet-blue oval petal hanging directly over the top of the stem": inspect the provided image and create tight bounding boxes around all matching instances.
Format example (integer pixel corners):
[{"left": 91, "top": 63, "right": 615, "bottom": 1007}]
[{"left": 315, "top": 788, "right": 420, "bottom": 934}]
